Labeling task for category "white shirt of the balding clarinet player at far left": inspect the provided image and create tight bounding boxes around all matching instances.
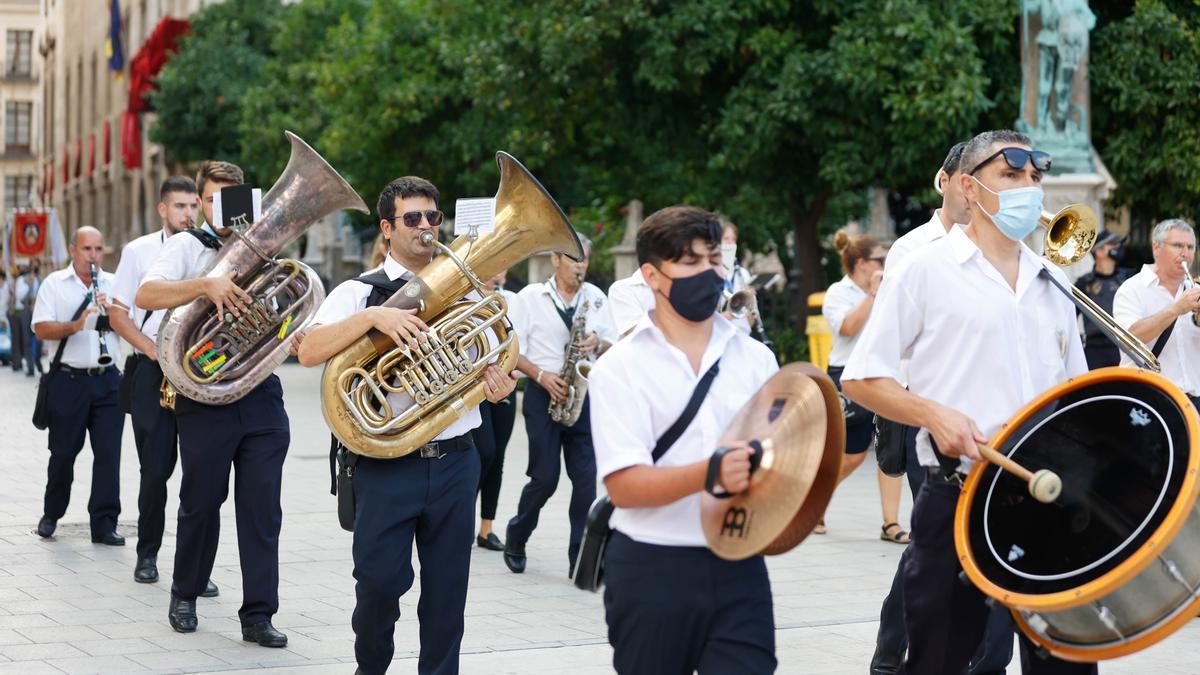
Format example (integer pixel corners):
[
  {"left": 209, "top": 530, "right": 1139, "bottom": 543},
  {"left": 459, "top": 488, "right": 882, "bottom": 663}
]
[{"left": 30, "top": 265, "right": 121, "bottom": 368}]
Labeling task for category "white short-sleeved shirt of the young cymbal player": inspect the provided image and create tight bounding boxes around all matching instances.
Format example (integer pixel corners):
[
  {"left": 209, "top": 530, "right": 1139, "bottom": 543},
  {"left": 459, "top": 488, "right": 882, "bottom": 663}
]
[{"left": 588, "top": 311, "right": 779, "bottom": 546}]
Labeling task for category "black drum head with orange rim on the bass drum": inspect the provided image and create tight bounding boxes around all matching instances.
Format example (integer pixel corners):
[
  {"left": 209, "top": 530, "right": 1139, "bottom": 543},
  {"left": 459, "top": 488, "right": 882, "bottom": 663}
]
[{"left": 955, "top": 369, "right": 1195, "bottom": 607}]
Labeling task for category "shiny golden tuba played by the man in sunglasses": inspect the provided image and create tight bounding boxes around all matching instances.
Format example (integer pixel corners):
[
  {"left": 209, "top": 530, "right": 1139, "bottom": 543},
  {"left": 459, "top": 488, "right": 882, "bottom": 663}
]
[{"left": 320, "top": 153, "right": 583, "bottom": 458}]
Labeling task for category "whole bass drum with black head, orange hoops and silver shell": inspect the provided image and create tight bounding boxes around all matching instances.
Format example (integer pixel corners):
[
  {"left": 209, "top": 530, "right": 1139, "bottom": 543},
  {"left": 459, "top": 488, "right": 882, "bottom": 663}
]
[{"left": 954, "top": 368, "right": 1200, "bottom": 662}]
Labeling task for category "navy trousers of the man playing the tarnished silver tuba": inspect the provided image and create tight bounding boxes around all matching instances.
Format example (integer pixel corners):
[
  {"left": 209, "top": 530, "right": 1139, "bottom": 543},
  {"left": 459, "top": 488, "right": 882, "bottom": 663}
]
[{"left": 169, "top": 369, "right": 290, "bottom": 626}]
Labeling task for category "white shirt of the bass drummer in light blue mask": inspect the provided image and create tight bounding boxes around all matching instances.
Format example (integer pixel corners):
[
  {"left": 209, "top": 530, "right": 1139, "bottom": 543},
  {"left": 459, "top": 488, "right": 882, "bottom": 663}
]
[{"left": 842, "top": 223, "right": 1087, "bottom": 472}]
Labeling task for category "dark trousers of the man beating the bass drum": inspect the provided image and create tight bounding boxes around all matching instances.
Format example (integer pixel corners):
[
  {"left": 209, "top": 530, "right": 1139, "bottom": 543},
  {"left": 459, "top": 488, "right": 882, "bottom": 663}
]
[{"left": 898, "top": 480, "right": 1097, "bottom": 675}]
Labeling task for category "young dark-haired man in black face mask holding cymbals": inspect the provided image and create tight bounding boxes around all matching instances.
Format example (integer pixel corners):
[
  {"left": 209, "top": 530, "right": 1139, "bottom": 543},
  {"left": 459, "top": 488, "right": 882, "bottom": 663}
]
[{"left": 590, "top": 207, "right": 778, "bottom": 675}]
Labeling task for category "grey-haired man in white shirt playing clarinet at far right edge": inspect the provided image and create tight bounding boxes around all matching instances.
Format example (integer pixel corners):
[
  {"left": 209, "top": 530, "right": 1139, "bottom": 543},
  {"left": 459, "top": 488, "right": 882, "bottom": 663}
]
[{"left": 1112, "top": 219, "right": 1200, "bottom": 404}]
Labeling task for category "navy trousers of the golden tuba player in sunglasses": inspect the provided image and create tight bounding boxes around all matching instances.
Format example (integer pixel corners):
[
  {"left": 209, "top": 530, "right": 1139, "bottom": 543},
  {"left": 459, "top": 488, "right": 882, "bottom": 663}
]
[{"left": 352, "top": 448, "right": 479, "bottom": 675}]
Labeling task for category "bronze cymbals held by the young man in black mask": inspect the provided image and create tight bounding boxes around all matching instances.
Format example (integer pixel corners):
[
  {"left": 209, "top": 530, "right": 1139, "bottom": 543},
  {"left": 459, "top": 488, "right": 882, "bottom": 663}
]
[{"left": 700, "top": 363, "right": 846, "bottom": 560}]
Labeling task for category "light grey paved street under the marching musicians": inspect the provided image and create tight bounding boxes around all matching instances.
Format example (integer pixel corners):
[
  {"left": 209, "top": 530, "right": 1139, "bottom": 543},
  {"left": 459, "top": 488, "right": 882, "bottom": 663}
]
[{"left": 0, "top": 365, "right": 1200, "bottom": 675}]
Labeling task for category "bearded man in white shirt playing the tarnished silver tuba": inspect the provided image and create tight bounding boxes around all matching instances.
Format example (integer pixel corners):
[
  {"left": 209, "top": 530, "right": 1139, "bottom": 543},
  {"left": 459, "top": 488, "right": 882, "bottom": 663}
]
[{"left": 133, "top": 161, "right": 290, "bottom": 647}]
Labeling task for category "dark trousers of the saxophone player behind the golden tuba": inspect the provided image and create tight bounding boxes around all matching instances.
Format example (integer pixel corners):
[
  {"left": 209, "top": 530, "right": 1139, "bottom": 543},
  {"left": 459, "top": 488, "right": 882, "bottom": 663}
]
[{"left": 505, "top": 382, "right": 596, "bottom": 565}]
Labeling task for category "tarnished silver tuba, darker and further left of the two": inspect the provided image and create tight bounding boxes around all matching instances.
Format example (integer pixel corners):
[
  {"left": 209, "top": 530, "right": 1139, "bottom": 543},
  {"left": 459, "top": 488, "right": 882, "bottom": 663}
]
[{"left": 158, "top": 131, "right": 367, "bottom": 405}]
